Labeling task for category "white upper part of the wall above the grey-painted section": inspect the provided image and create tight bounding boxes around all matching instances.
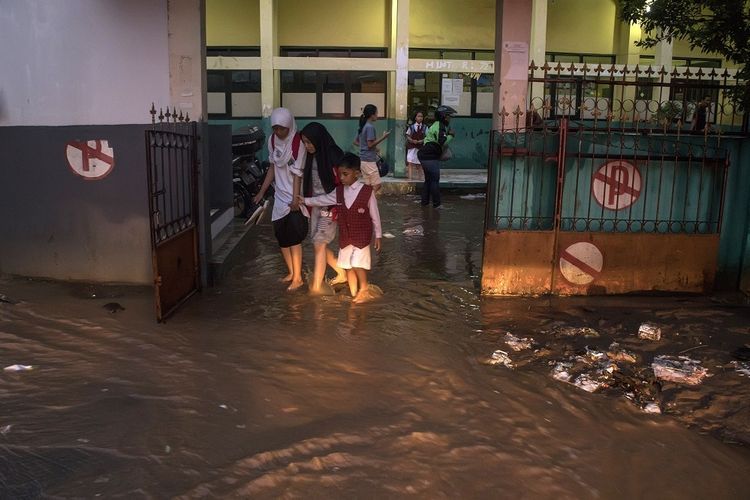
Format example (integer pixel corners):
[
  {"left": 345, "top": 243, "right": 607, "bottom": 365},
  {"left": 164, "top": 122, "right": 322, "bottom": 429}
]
[{"left": 0, "top": 0, "right": 170, "bottom": 126}]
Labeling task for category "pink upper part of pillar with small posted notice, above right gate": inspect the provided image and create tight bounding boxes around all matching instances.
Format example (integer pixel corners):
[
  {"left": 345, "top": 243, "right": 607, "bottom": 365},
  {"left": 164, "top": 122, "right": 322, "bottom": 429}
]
[{"left": 492, "top": 0, "right": 532, "bottom": 130}]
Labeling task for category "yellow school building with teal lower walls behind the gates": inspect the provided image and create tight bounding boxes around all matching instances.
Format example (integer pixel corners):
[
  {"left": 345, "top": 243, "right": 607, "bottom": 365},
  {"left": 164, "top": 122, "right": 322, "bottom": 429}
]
[{"left": 201, "top": 0, "right": 740, "bottom": 176}]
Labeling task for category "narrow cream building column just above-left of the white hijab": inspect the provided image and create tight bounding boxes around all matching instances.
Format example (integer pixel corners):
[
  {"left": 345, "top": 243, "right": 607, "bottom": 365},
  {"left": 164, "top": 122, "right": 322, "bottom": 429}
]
[{"left": 260, "top": 0, "right": 279, "bottom": 118}]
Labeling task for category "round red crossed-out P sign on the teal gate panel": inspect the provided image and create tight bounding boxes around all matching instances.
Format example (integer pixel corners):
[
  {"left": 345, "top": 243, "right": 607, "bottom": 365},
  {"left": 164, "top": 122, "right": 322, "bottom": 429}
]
[{"left": 591, "top": 160, "right": 641, "bottom": 210}]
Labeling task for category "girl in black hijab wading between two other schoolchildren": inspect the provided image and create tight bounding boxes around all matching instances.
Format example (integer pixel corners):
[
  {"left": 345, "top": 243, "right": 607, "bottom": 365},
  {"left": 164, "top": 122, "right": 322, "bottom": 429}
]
[{"left": 295, "top": 122, "right": 346, "bottom": 294}]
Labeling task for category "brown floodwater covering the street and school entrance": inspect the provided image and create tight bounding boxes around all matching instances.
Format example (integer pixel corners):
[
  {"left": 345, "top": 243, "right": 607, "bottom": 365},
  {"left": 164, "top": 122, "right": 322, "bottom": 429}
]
[{"left": 0, "top": 196, "right": 750, "bottom": 499}]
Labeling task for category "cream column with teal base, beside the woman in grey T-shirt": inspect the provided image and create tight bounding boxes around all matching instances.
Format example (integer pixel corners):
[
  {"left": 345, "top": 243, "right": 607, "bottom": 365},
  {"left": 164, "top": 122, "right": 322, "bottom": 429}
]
[{"left": 389, "top": 0, "right": 410, "bottom": 177}]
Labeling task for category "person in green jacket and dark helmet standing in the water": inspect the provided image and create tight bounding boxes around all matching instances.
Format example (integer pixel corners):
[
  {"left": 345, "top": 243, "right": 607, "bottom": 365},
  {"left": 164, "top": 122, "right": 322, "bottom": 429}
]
[{"left": 417, "top": 106, "right": 456, "bottom": 208}]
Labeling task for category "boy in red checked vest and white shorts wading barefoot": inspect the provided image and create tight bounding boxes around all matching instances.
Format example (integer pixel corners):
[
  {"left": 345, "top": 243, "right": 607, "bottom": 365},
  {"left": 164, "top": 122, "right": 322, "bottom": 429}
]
[{"left": 300, "top": 153, "right": 382, "bottom": 304}]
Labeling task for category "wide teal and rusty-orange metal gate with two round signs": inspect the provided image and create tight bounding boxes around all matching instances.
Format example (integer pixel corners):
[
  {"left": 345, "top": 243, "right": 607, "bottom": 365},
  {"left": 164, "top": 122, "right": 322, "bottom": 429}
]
[{"left": 482, "top": 65, "right": 745, "bottom": 295}]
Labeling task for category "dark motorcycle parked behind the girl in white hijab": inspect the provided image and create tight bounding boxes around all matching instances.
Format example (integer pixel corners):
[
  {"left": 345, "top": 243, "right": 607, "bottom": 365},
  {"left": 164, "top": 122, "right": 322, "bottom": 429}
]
[{"left": 232, "top": 127, "right": 273, "bottom": 224}]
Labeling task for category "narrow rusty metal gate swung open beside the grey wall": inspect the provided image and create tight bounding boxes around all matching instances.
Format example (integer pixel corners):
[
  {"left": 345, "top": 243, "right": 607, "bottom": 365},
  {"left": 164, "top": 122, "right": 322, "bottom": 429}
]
[{"left": 146, "top": 106, "right": 200, "bottom": 321}]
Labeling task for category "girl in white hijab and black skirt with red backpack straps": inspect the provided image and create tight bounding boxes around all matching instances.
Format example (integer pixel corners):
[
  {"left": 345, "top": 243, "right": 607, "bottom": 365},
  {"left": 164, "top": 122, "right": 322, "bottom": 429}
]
[{"left": 253, "top": 108, "right": 308, "bottom": 291}]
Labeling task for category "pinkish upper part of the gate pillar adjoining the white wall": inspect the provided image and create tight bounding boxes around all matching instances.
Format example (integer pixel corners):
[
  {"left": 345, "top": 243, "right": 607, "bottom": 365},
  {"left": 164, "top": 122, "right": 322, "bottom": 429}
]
[{"left": 168, "top": 0, "right": 208, "bottom": 121}]
